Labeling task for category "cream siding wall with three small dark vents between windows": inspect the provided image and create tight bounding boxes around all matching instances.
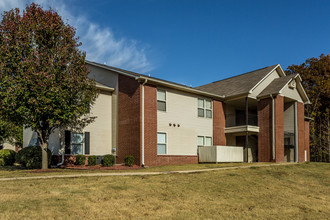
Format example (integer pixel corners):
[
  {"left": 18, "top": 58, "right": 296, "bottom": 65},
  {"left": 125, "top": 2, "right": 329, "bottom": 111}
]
[{"left": 157, "top": 88, "right": 213, "bottom": 156}]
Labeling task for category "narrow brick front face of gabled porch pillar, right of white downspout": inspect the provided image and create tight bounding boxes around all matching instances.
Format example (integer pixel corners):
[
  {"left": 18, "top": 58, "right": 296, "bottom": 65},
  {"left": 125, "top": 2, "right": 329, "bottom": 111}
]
[{"left": 274, "top": 95, "right": 284, "bottom": 162}]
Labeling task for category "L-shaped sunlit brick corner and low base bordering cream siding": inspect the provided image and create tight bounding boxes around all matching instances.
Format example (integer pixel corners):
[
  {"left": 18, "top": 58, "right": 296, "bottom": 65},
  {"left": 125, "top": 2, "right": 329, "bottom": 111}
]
[{"left": 144, "top": 85, "right": 198, "bottom": 166}]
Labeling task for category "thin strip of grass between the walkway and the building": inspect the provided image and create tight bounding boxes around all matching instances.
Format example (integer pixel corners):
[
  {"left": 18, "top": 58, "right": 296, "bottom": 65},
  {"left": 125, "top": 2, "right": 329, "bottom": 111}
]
[{"left": 0, "top": 163, "right": 269, "bottom": 178}]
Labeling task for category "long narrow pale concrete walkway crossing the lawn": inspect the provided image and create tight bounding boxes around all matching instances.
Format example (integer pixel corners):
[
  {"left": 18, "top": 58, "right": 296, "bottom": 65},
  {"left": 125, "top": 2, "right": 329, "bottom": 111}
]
[{"left": 0, "top": 163, "right": 297, "bottom": 182}]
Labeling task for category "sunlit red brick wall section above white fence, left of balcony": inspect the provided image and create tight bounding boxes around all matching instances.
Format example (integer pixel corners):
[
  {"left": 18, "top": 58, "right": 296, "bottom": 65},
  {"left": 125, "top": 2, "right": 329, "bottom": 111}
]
[{"left": 213, "top": 100, "right": 226, "bottom": 145}]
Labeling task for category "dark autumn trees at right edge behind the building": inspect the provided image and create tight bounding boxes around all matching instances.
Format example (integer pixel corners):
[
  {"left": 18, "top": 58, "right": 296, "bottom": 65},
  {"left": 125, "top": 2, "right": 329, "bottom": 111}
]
[{"left": 286, "top": 54, "right": 330, "bottom": 162}]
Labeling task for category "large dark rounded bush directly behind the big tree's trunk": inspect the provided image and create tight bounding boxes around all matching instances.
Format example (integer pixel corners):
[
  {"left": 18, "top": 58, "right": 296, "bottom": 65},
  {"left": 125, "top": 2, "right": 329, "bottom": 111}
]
[{"left": 16, "top": 146, "right": 52, "bottom": 169}]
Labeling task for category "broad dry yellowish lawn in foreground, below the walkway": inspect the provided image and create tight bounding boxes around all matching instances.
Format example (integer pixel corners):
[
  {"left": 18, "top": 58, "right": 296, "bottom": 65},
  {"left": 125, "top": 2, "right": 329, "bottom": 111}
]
[{"left": 0, "top": 163, "right": 330, "bottom": 219}]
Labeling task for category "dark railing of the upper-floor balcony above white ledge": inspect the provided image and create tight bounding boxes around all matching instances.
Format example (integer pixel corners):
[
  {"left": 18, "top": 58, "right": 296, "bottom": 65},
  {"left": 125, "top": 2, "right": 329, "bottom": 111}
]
[{"left": 226, "top": 113, "right": 258, "bottom": 127}]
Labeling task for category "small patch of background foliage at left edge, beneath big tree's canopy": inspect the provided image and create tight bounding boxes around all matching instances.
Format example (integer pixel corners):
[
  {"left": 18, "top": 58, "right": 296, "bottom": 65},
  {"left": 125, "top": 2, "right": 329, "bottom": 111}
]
[{"left": 0, "top": 119, "right": 23, "bottom": 147}]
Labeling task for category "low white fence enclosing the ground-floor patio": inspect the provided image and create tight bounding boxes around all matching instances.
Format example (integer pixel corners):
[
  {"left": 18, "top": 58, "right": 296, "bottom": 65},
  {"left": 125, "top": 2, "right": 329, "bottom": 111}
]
[{"left": 198, "top": 146, "right": 244, "bottom": 163}]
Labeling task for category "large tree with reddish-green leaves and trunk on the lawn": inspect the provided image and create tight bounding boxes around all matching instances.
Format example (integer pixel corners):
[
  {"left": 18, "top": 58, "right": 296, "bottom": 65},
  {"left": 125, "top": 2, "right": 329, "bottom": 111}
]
[{"left": 0, "top": 3, "right": 97, "bottom": 169}]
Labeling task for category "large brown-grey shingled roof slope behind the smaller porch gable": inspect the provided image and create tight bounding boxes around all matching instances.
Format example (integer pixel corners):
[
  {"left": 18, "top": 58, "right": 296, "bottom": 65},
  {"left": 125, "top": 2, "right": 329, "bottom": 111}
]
[{"left": 196, "top": 64, "right": 278, "bottom": 97}]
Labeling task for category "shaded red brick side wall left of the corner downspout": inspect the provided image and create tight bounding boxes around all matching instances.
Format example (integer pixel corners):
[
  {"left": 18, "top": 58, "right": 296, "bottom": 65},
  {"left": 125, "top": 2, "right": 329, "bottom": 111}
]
[{"left": 116, "top": 74, "right": 141, "bottom": 165}]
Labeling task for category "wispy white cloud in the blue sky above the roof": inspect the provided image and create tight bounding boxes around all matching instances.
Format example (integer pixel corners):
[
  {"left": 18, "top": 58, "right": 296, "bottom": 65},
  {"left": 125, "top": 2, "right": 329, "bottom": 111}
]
[{"left": 0, "top": 0, "right": 153, "bottom": 73}]
